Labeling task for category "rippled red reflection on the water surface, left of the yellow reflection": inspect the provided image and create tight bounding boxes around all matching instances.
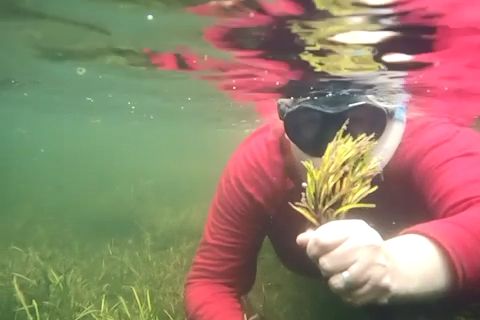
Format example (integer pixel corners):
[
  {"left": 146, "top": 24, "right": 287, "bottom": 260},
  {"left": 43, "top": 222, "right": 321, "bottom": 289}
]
[{"left": 145, "top": 0, "right": 304, "bottom": 117}]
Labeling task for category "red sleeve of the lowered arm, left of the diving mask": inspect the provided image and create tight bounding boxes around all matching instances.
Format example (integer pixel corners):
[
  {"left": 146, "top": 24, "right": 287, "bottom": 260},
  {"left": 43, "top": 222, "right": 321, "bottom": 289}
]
[{"left": 185, "top": 121, "right": 286, "bottom": 320}]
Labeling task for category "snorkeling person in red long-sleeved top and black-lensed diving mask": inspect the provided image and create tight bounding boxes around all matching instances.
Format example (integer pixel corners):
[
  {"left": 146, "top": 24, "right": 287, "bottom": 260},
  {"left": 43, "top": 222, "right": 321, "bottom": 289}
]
[{"left": 185, "top": 87, "right": 480, "bottom": 320}]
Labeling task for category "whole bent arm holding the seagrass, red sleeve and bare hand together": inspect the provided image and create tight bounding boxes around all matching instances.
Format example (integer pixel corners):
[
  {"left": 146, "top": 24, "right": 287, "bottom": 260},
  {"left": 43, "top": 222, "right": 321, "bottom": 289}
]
[{"left": 298, "top": 121, "right": 480, "bottom": 304}]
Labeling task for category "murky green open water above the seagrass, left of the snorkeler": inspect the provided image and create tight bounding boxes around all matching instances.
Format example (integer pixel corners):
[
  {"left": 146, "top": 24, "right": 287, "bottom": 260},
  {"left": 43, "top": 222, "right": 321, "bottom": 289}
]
[{"left": 0, "top": 1, "right": 254, "bottom": 242}]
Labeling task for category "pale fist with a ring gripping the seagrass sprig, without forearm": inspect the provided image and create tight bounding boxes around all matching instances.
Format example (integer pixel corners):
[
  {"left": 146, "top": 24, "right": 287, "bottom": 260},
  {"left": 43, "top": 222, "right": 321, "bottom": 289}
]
[{"left": 297, "top": 220, "right": 393, "bottom": 305}]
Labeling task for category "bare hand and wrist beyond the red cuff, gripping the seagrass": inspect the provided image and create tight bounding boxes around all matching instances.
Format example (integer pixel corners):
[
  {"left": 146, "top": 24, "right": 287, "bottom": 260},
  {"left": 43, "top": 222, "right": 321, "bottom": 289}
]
[{"left": 297, "top": 220, "right": 452, "bottom": 305}]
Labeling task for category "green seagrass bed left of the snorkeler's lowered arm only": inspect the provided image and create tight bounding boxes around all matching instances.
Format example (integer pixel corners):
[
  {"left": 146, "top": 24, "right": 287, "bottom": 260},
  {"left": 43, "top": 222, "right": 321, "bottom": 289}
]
[{"left": 0, "top": 234, "right": 193, "bottom": 320}]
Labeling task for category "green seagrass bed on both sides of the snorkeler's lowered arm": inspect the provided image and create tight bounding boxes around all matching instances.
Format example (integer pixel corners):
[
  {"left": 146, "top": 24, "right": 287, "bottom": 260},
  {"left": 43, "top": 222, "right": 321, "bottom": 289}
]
[{"left": 0, "top": 184, "right": 480, "bottom": 320}]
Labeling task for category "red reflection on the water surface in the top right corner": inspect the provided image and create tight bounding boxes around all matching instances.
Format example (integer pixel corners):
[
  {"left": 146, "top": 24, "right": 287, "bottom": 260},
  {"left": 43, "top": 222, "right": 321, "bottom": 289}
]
[{"left": 399, "top": 0, "right": 480, "bottom": 126}]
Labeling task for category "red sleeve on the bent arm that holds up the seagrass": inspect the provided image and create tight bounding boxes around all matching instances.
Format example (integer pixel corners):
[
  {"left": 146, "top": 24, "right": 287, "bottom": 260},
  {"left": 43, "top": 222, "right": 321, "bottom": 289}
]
[{"left": 402, "top": 120, "right": 480, "bottom": 291}]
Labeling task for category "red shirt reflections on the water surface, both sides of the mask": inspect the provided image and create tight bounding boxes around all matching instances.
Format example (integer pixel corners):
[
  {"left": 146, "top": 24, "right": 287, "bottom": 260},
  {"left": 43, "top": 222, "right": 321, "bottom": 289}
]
[{"left": 146, "top": 0, "right": 480, "bottom": 125}]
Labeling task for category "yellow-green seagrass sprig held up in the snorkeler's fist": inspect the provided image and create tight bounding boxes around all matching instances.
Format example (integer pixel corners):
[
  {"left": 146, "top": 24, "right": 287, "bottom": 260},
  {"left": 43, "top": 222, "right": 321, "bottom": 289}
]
[{"left": 290, "top": 121, "right": 381, "bottom": 226}]
